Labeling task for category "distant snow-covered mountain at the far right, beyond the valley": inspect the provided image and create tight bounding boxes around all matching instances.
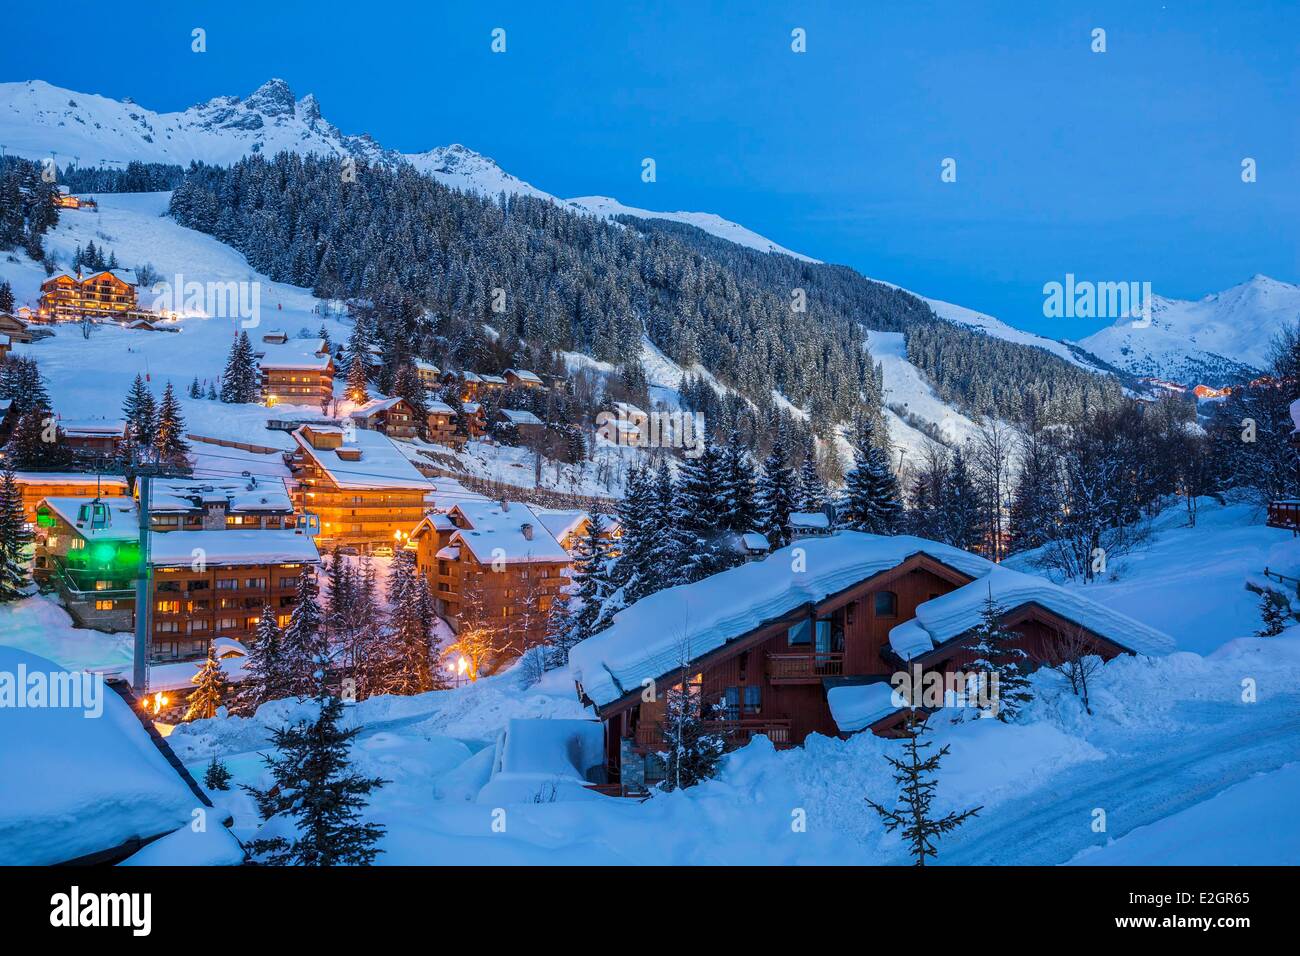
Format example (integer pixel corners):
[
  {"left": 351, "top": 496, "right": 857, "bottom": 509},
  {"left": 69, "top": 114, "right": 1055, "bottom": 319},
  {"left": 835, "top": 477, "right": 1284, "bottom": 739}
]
[{"left": 1079, "top": 276, "right": 1300, "bottom": 385}]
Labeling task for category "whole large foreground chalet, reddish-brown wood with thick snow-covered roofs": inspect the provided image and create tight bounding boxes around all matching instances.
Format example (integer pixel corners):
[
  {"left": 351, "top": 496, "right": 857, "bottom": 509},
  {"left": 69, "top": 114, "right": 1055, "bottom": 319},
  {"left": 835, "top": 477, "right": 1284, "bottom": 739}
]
[{"left": 569, "top": 532, "right": 1174, "bottom": 791}]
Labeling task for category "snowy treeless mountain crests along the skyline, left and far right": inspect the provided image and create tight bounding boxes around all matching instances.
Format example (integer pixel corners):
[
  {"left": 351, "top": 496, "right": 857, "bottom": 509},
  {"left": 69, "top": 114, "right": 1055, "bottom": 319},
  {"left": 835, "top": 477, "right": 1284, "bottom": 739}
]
[{"left": 0, "top": 79, "right": 1300, "bottom": 385}]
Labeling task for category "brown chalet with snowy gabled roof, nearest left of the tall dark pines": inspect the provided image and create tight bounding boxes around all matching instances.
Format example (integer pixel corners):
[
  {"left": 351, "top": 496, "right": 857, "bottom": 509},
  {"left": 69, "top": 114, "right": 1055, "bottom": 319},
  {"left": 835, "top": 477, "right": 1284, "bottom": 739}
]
[{"left": 411, "top": 501, "right": 571, "bottom": 659}]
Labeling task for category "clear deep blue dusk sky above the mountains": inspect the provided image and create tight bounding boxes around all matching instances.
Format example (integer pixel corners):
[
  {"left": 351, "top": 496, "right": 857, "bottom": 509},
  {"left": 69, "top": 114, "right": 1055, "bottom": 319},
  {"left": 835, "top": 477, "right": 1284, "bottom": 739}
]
[{"left": 0, "top": 0, "right": 1300, "bottom": 338}]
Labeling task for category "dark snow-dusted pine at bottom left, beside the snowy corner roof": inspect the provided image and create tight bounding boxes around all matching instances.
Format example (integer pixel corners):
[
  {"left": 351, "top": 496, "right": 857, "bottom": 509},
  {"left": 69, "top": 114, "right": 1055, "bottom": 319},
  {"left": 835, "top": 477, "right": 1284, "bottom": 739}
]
[{"left": 244, "top": 658, "right": 386, "bottom": 866}]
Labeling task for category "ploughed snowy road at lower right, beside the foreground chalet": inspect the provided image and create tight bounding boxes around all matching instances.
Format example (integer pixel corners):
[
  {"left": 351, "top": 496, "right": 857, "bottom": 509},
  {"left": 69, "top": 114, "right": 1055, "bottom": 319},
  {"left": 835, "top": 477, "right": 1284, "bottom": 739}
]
[{"left": 939, "top": 695, "right": 1300, "bottom": 865}]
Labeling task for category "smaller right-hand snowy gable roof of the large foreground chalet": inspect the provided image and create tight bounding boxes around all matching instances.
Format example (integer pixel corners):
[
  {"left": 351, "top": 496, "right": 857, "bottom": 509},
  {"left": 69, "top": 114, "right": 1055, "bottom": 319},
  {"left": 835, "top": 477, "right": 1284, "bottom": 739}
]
[{"left": 889, "top": 567, "right": 1174, "bottom": 661}]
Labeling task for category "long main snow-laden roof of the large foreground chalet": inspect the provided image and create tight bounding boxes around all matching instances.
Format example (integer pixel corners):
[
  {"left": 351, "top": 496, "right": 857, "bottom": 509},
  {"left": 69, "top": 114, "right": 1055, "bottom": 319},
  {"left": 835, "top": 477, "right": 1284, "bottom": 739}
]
[{"left": 569, "top": 531, "right": 993, "bottom": 705}]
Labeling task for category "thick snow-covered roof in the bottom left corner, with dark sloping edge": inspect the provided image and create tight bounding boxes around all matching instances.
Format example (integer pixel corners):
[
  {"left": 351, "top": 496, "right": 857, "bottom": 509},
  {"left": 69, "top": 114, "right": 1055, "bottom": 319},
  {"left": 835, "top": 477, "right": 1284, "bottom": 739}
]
[{"left": 0, "top": 646, "right": 200, "bottom": 865}]
